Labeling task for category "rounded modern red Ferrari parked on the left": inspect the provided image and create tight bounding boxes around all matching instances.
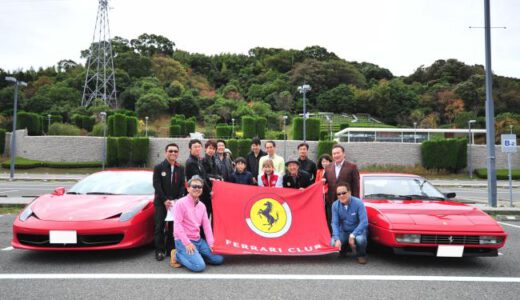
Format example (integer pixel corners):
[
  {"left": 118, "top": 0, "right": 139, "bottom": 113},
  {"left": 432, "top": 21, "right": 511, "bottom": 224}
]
[{"left": 11, "top": 170, "right": 154, "bottom": 250}]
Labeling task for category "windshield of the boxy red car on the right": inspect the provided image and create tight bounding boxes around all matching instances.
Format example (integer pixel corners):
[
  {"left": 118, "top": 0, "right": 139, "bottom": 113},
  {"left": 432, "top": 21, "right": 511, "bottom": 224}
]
[{"left": 363, "top": 176, "right": 445, "bottom": 200}]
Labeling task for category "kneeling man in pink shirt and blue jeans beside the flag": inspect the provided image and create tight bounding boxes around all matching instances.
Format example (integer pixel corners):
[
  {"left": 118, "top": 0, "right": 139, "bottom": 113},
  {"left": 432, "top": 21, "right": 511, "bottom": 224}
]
[{"left": 170, "top": 175, "right": 224, "bottom": 272}]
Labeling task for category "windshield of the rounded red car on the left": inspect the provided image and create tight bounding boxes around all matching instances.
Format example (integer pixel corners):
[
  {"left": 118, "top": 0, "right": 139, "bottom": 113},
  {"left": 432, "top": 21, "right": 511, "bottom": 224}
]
[{"left": 67, "top": 171, "right": 154, "bottom": 195}]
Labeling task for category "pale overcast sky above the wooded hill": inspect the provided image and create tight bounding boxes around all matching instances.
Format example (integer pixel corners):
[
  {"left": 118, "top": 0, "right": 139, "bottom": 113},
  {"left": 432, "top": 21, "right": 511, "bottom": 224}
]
[{"left": 0, "top": 0, "right": 520, "bottom": 78}]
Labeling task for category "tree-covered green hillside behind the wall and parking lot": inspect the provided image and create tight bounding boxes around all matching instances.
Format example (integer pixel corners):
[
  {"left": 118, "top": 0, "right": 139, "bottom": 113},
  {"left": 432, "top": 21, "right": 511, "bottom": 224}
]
[{"left": 0, "top": 34, "right": 520, "bottom": 136}]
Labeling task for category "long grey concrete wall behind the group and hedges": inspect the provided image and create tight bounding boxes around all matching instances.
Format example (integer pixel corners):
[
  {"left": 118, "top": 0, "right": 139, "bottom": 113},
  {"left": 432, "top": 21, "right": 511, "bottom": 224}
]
[{"left": 5, "top": 130, "right": 520, "bottom": 169}]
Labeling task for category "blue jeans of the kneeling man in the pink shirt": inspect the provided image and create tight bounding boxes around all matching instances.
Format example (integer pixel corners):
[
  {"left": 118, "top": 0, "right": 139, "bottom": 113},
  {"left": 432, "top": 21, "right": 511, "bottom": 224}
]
[{"left": 175, "top": 239, "right": 224, "bottom": 272}]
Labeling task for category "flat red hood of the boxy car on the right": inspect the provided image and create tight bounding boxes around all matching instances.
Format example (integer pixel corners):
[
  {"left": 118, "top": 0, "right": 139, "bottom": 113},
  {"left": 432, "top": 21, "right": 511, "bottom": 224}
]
[{"left": 365, "top": 200, "right": 503, "bottom": 232}]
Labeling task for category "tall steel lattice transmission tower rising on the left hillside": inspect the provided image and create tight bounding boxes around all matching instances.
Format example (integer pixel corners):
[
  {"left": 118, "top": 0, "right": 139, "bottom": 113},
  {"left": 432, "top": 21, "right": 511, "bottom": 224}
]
[{"left": 81, "top": 0, "right": 117, "bottom": 108}]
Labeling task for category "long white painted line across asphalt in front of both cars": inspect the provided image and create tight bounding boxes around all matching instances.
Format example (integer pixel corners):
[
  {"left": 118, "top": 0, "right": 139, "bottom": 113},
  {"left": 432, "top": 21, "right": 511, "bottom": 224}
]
[{"left": 0, "top": 273, "right": 520, "bottom": 283}]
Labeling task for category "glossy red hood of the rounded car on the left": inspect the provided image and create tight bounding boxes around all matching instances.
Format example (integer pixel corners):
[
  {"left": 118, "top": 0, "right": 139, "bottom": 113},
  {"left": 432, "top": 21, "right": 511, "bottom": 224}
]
[{"left": 31, "top": 194, "right": 153, "bottom": 221}]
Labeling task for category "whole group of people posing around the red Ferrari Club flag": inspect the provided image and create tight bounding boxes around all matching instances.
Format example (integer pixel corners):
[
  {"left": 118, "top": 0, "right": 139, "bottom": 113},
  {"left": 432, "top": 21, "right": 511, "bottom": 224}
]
[{"left": 153, "top": 139, "right": 368, "bottom": 272}]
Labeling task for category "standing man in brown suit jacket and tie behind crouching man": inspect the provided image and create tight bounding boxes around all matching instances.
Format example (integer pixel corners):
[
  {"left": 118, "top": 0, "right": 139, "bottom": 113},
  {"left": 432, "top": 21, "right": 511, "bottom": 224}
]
[{"left": 324, "top": 144, "right": 359, "bottom": 230}]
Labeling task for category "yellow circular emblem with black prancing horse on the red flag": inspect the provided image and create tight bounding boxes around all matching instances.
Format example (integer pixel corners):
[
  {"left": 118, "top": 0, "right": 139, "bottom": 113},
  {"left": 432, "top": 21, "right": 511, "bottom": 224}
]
[{"left": 246, "top": 198, "right": 292, "bottom": 238}]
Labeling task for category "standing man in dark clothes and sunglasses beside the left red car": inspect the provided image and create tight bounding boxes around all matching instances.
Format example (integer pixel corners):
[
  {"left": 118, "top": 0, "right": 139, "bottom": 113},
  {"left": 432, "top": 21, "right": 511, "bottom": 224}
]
[{"left": 153, "top": 143, "right": 186, "bottom": 261}]
